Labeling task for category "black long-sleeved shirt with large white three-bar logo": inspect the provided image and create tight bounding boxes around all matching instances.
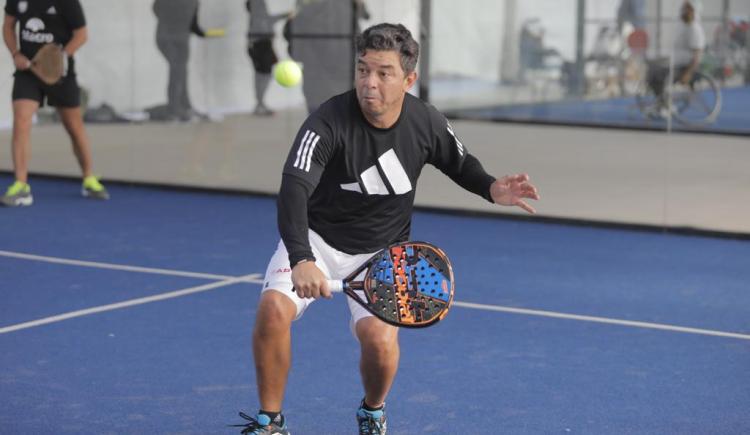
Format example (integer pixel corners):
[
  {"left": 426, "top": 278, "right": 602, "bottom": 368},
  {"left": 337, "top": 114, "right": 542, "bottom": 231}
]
[{"left": 279, "top": 90, "right": 494, "bottom": 261}]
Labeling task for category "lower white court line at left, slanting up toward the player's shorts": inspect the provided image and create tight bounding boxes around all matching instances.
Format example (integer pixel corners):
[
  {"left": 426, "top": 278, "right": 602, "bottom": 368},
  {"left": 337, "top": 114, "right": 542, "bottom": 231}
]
[{"left": 0, "top": 273, "right": 263, "bottom": 334}]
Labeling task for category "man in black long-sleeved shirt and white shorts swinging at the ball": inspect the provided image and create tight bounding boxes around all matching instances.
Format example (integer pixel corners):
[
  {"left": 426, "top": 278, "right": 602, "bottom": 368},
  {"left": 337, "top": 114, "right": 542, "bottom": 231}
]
[{"left": 240, "top": 23, "right": 539, "bottom": 435}]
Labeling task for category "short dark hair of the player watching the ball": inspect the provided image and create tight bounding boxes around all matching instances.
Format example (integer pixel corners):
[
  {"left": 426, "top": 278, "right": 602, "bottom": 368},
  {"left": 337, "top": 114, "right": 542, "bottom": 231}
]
[{"left": 356, "top": 23, "right": 419, "bottom": 74}]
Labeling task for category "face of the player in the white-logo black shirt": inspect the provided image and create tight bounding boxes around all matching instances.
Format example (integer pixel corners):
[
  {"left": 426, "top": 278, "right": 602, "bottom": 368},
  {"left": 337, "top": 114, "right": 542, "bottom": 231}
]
[{"left": 354, "top": 50, "right": 417, "bottom": 126}]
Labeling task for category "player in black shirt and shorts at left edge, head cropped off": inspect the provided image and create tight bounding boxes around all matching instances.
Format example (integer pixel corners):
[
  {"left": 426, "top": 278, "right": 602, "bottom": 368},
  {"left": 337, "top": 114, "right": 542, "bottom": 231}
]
[{"left": 0, "top": 0, "right": 109, "bottom": 207}]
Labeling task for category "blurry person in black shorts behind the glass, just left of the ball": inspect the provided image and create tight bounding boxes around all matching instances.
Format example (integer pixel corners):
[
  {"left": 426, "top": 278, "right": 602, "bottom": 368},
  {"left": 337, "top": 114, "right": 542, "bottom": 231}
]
[{"left": 250, "top": 0, "right": 290, "bottom": 116}]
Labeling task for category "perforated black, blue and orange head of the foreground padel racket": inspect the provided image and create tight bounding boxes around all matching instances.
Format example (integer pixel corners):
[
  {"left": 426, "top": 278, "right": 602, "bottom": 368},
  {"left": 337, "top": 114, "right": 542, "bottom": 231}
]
[{"left": 364, "top": 242, "right": 454, "bottom": 327}]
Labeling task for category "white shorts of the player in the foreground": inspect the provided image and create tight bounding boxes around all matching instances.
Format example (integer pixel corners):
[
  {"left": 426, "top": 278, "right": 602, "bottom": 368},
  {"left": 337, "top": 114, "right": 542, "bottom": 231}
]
[{"left": 261, "top": 230, "right": 375, "bottom": 332}]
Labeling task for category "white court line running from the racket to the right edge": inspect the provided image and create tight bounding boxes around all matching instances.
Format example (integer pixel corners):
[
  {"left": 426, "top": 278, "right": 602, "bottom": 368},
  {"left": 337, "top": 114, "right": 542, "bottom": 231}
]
[{"left": 453, "top": 302, "right": 750, "bottom": 340}]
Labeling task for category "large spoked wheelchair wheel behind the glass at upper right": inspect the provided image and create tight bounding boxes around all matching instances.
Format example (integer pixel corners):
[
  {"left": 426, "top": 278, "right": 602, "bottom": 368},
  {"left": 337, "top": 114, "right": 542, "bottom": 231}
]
[{"left": 672, "top": 72, "right": 721, "bottom": 126}]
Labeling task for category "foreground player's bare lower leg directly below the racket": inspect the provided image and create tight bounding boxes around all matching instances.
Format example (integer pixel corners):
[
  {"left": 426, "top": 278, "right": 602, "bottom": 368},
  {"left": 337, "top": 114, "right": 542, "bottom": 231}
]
[{"left": 355, "top": 317, "right": 400, "bottom": 408}]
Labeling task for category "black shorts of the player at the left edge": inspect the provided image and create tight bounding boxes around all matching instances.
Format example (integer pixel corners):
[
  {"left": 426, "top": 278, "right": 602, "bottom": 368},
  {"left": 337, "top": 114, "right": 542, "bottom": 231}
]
[{"left": 13, "top": 71, "right": 81, "bottom": 107}]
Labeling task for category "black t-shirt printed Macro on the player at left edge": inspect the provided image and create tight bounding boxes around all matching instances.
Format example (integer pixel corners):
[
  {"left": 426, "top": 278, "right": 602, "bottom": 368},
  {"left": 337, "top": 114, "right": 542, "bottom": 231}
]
[{"left": 5, "top": 0, "right": 86, "bottom": 66}]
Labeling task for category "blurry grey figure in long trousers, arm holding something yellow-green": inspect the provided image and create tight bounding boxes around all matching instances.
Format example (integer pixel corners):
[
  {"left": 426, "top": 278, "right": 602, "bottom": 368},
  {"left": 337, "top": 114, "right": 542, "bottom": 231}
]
[{"left": 149, "top": 0, "right": 224, "bottom": 121}]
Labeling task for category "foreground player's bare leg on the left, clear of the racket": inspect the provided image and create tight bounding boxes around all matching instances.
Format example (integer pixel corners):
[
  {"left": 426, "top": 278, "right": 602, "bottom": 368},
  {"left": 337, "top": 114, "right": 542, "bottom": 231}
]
[{"left": 253, "top": 290, "right": 297, "bottom": 412}]
